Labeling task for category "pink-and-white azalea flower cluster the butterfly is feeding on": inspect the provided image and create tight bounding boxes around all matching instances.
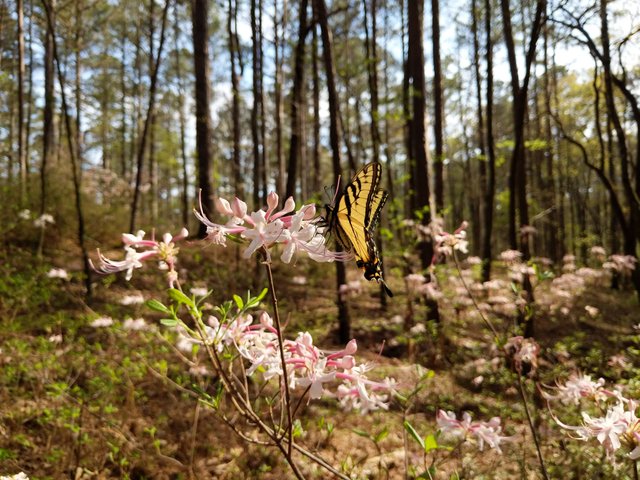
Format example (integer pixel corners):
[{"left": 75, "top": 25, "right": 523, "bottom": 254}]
[{"left": 195, "top": 192, "right": 351, "bottom": 263}]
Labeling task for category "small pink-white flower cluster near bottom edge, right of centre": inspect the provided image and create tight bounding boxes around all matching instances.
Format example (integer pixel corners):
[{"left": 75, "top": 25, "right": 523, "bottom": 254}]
[{"left": 436, "top": 410, "right": 512, "bottom": 453}]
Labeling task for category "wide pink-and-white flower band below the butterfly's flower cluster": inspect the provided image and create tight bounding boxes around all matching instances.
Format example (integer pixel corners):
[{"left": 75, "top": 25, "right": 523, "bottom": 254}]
[{"left": 177, "top": 312, "right": 395, "bottom": 413}]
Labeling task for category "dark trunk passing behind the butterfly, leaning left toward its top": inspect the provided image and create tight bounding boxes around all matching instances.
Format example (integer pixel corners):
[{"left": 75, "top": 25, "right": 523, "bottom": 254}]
[{"left": 313, "top": 0, "right": 351, "bottom": 343}]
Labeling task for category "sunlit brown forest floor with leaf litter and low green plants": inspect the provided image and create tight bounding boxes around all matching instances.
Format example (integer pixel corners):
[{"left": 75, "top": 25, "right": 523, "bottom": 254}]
[{"left": 0, "top": 242, "right": 640, "bottom": 480}]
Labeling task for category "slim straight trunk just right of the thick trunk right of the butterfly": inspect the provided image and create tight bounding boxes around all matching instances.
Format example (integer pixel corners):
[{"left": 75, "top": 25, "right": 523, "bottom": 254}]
[{"left": 431, "top": 0, "right": 444, "bottom": 215}]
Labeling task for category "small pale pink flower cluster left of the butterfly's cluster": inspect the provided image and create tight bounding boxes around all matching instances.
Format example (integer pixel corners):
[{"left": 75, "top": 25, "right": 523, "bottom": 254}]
[{"left": 92, "top": 228, "right": 189, "bottom": 288}]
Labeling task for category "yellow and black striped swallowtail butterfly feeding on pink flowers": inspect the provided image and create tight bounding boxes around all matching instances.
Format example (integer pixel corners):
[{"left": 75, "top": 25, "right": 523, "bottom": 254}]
[{"left": 325, "top": 162, "right": 393, "bottom": 297}]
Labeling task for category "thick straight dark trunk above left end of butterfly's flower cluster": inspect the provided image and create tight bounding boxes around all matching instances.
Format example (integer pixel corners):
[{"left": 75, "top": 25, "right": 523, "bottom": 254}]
[{"left": 192, "top": 0, "right": 213, "bottom": 238}]
